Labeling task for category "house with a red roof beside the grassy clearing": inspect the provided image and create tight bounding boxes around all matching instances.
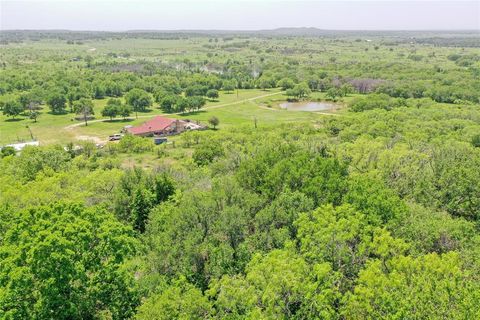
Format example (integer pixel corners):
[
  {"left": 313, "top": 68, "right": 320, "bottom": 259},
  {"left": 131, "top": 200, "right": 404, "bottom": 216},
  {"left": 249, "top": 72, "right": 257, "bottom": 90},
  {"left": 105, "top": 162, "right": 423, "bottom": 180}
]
[{"left": 126, "top": 116, "right": 185, "bottom": 137}]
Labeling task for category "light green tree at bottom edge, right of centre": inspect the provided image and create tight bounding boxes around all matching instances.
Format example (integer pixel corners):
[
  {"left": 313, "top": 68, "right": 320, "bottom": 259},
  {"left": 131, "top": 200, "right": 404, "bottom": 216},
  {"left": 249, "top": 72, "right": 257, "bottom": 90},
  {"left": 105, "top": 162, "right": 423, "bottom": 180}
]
[{"left": 206, "top": 249, "right": 338, "bottom": 319}]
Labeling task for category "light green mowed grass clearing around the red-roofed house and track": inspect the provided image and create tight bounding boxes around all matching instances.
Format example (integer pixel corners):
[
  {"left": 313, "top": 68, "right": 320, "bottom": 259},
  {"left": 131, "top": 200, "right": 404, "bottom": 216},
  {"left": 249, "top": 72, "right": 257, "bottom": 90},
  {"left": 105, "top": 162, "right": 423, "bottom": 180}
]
[{"left": 0, "top": 89, "right": 344, "bottom": 145}]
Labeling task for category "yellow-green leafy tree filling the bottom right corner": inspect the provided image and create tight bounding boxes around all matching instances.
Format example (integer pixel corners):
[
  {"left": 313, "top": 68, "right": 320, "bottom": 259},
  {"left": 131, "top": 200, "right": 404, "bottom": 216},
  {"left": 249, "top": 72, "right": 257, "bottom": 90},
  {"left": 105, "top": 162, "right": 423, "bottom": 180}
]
[{"left": 342, "top": 252, "right": 480, "bottom": 319}]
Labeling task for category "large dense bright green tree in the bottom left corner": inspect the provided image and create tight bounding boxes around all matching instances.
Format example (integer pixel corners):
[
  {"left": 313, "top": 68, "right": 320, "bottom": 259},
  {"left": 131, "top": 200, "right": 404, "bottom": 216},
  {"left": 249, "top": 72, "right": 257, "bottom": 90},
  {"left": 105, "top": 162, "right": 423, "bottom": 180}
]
[{"left": 0, "top": 203, "right": 138, "bottom": 319}]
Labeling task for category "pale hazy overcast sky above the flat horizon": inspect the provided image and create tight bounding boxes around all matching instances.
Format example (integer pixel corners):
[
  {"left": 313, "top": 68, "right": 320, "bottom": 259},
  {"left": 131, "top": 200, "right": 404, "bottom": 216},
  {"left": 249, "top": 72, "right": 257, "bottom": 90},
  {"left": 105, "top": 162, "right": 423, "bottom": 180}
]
[{"left": 0, "top": 0, "right": 480, "bottom": 31}]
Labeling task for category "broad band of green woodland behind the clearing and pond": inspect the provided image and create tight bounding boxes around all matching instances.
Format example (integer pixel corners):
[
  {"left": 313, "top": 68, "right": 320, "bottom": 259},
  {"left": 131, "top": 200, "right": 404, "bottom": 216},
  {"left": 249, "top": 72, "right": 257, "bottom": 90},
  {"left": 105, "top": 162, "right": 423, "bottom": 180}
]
[{"left": 0, "top": 35, "right": 480, "bottom": 120}]
